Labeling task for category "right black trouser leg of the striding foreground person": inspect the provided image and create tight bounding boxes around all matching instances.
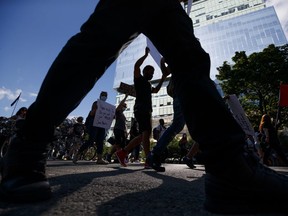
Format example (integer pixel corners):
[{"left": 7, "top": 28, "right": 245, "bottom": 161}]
[{"left": 145, "top": 0, "right": 245, "bottom": 161}]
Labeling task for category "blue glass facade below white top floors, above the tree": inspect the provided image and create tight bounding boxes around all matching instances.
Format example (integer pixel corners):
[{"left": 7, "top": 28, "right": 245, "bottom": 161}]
[{"left": 195, "top": 7, "right": 287, "bottom": 79}]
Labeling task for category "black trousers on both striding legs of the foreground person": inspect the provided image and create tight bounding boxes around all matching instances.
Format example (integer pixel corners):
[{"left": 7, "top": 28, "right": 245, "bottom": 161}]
[{"left": 26, "top": 0, "right": 245, "bottom": 167}]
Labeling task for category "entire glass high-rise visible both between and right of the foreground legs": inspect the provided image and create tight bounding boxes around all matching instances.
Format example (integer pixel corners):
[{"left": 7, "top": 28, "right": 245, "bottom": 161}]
[{"left": 113, "top": 0, "right": 287, "bottom": 132}]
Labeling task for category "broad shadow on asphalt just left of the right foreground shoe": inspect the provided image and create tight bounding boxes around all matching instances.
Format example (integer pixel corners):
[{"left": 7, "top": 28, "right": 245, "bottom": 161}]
[{"left": 97, "top": 171, "right": 209, "bottom": 216}]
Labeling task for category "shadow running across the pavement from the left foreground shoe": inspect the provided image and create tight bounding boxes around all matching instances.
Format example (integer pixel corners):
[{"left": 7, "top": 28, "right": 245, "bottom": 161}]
[{"left": 0, "top": 165, "right": 138, "bottom": 216}]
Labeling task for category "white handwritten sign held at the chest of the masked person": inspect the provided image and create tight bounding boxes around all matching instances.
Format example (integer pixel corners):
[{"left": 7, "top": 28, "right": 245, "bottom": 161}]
[{"left": 93, "top": 99, "right": 115, "bottom": 129}]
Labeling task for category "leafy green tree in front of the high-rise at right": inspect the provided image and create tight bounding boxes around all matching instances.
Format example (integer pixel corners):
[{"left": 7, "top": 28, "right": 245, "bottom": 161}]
[{"left": 216, "top": 44, "right": 288, "bottom": 127}]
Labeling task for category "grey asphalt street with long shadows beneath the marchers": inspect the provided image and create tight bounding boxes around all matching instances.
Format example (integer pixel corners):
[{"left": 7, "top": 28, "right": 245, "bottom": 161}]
[{"left": 0, "top": 161, "right": 288, "bottom": 216}]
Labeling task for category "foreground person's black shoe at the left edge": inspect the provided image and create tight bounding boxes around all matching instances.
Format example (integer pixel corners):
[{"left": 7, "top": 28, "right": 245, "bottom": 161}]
[{"left": 0, "top": 137, "right": 52, "bottom": 202}]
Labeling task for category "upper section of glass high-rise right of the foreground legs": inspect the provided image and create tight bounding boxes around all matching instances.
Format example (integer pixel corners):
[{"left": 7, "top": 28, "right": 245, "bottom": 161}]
[{"left": 190, "top": 0, "right": 287, "bottom": 79}]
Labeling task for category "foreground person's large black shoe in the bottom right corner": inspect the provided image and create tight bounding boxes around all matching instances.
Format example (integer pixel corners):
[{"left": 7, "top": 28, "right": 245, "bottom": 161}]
[{"left": 204, "top": 151, "right": 288, "bottom": 214}]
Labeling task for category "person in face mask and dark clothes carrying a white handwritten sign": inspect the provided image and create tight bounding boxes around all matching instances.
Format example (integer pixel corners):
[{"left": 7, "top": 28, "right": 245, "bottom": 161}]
[{"left": 72, "top": 91, "right": 108, "bottom": 164}]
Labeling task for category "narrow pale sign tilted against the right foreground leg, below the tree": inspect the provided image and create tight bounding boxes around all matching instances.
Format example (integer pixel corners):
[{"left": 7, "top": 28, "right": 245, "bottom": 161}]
[{"left": 227, "top": 94, "right": 255, "bottom": 136}]
